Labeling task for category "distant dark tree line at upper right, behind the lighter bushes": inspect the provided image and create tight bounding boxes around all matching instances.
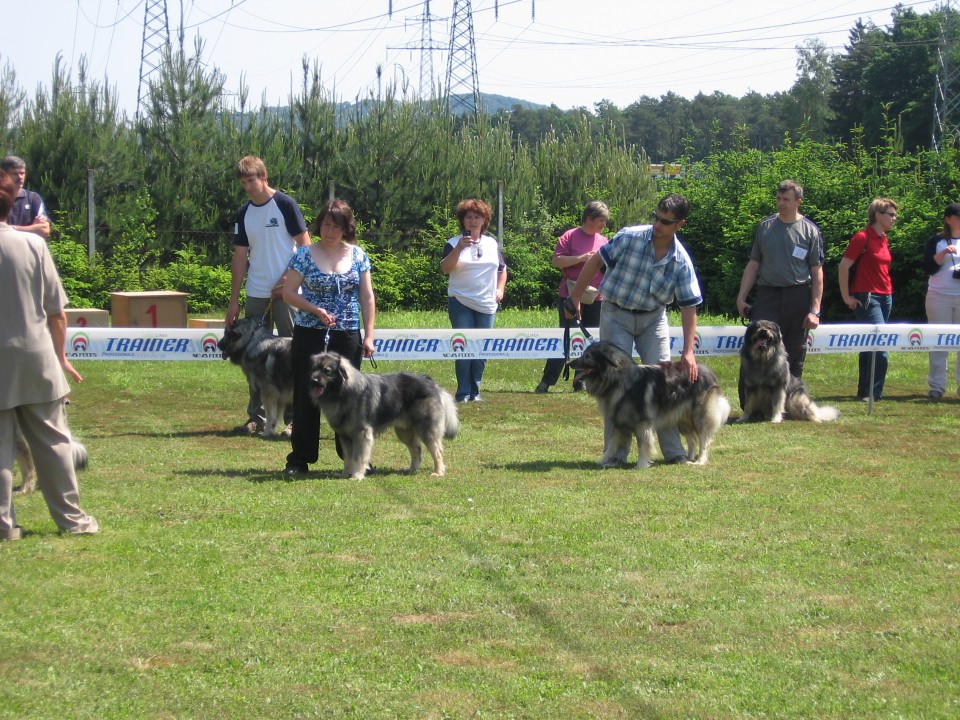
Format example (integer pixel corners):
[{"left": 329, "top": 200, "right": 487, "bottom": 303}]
[{"left": 499, "top": 6, "right": 960, "bottom": 162}]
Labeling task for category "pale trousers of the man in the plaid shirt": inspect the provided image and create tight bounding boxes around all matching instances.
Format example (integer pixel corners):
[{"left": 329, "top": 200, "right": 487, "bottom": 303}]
[{"left": 600, "top": 302, "right": 687, "bottom": 460}]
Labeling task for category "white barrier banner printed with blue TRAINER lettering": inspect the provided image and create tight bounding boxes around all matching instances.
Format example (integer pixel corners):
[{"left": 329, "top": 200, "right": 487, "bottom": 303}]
[{"left": 66, "top": 323, "right": 960, "bottom": 361}]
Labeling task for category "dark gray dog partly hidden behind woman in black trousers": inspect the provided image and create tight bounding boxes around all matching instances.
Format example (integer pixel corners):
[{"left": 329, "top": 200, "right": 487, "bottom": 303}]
[{"left": 217, "top": 318, "right": 293, "bottom": 437}]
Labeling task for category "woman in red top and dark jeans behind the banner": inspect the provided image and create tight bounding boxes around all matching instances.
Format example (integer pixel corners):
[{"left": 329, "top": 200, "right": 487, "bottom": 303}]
[{"left": 839, "top": 198, "right": 898, "bottom": 401}]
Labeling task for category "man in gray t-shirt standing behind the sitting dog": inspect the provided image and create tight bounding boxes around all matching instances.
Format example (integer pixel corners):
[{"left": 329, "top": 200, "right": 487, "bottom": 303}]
[{"left": 737, "top": 180, "right": 823, "bottom": 388}]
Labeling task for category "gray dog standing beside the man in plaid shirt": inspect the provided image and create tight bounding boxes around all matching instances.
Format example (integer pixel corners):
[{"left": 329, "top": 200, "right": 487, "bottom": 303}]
[{"left": 570, "top": 341, "right": 730, "bottom": 468}]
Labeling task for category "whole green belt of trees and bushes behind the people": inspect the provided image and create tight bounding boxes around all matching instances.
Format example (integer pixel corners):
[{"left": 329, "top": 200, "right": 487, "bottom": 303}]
[{"left": 0, "top": 8, "right": 960, "bottom": 320}]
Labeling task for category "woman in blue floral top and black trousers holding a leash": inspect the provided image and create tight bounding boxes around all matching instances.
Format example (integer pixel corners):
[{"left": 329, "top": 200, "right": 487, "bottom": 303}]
[{"left": 283, "top": 200, "right": 377, "bottom": 475}]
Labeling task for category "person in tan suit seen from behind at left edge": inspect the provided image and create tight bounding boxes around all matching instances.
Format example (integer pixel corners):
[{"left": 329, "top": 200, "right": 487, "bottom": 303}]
[{"left": 0, "top": 172, "right": 99, "bottom": 540}]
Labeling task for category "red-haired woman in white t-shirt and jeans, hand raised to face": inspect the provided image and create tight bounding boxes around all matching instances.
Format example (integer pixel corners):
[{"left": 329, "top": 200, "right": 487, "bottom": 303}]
[{"left": 440, "top": 198, "right": 507, "bottom": 402}]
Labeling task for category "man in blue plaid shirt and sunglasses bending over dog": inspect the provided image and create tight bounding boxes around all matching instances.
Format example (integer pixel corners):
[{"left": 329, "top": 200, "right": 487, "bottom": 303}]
[{"left": 570, "top": 194, "right": 703, "bottom": 464}]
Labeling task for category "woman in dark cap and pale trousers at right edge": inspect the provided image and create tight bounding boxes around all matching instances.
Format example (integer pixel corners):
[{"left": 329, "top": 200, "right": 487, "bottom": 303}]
[{"left": 923, "top": 203, "right": 960, "bottom": 400}]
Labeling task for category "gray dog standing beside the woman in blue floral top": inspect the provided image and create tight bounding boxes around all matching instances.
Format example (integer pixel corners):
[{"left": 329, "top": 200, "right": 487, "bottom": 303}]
[{"left": 310, "top": 352, "right": 460, "bottom": 480}]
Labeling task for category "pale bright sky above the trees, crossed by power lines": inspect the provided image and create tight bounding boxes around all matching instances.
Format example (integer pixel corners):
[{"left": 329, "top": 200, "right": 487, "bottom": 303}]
[{"left": 0, "top": 0, "right": 945, "bottom": 115}]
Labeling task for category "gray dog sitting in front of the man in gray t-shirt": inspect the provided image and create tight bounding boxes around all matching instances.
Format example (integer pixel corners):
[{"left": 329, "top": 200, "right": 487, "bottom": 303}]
[{"left": 737, "top": 320, "right": 840, "bottom": 423}]
